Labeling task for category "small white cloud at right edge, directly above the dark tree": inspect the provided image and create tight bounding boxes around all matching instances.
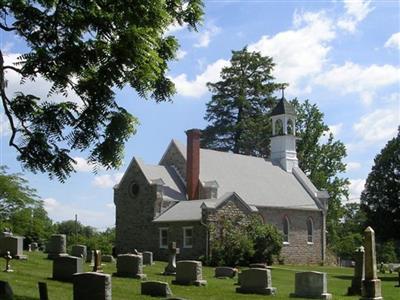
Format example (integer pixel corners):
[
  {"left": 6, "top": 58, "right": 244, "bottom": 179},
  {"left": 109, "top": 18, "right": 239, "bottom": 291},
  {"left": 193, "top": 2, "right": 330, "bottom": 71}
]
[{"left": 353, "top": 108, "right": 400, "bottom": 144}]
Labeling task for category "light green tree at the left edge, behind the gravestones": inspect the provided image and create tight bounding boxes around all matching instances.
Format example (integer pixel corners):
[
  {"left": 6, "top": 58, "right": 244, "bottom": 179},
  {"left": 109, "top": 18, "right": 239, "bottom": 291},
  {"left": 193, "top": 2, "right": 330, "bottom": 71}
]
[{"left": 0, "top": 166, "right": 39, "bottom": 224}]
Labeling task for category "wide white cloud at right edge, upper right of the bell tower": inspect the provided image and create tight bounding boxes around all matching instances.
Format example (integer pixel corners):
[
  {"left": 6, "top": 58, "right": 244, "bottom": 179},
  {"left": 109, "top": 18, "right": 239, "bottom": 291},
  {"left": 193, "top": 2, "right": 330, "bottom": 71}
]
[{"left": 314, "top": 62, "right": 400, "bottom": 104}]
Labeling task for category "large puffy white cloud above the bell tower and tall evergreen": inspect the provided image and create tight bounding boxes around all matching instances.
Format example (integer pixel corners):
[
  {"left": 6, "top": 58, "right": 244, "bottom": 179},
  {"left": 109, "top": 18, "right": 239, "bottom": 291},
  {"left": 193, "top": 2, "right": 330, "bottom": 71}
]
[{"left": 248, "top": 11, "right": 335, "bottom": 94}]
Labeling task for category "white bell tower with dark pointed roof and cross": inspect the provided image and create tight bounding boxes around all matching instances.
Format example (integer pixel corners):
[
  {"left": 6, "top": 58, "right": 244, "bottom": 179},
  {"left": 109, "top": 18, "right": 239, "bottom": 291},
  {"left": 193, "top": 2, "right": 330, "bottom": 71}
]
[{"left": 271, "top": 89, "right": 299, "bottom": 172}]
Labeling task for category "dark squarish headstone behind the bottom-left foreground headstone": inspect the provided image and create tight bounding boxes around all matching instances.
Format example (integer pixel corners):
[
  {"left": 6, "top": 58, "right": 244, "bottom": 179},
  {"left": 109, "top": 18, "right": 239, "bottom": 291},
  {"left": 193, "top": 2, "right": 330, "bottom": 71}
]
[{"left": 53, "top": 256, "right": 83, "bottom": 281}]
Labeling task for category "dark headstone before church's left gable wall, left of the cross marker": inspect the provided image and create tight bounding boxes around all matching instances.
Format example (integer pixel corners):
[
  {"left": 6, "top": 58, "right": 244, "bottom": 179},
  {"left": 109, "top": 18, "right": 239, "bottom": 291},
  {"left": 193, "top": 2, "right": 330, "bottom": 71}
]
[{"left": 115, "top": 254, "right": 147, "bottom": 279}]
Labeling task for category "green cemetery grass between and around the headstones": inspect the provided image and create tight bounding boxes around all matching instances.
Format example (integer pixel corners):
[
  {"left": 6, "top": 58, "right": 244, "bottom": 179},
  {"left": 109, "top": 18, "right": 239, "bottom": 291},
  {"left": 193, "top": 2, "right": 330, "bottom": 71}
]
[{"left": 0, "top": 252, "right": 400, "bottom": 300}]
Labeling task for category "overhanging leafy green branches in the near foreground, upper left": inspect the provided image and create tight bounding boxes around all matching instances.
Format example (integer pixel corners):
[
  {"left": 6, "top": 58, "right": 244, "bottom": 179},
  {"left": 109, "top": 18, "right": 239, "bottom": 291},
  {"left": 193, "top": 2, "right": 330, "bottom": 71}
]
[{"left": 0, "top": 0, "right": 203, "bottom": 181}]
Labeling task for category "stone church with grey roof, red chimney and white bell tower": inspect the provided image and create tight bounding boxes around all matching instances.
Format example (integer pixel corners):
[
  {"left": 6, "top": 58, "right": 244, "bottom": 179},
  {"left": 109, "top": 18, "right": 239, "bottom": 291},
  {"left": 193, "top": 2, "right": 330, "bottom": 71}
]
[{"left": 114, "top": 98, "right": 329, "bottom": 264}]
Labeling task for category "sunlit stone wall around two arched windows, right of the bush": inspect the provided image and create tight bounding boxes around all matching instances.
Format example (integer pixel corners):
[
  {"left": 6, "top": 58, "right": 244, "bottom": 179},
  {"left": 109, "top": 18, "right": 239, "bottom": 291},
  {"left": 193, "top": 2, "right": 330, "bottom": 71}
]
[{"left": 259, "top": 208, "right": 322, "bottom": 264}]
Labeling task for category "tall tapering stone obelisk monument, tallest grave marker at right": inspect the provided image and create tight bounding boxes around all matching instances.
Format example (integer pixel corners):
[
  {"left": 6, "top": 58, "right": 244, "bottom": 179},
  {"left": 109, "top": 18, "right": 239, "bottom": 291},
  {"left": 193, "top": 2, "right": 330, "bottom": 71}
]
[{"left": 361, "top": 227, "right": 383, "bottom": 300}]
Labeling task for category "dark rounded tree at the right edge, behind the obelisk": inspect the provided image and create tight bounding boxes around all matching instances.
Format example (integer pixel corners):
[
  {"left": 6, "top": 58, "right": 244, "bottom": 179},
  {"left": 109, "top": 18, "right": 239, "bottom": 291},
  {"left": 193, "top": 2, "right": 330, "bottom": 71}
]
[{"left": 361, "top": 127, "right": 400, "bottom": 242}]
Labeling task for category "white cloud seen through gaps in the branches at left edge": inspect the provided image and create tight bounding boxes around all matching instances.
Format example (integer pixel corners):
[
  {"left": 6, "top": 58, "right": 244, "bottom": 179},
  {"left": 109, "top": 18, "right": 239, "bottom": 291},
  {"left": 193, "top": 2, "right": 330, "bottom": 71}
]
[{"left": 4, "top": 53, "right": 82, "bottom": 105}]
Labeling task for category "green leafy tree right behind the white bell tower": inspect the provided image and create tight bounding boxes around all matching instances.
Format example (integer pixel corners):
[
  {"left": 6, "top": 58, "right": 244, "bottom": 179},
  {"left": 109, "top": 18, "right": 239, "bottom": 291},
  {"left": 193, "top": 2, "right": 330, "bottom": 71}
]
[{"left": 291, "top": 99, "right": 349, "bottom": 246}]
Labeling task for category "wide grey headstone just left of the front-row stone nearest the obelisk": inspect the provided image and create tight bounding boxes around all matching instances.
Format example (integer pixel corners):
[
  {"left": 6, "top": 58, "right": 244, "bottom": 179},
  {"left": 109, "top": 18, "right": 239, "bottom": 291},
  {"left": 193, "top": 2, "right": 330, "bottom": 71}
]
[{"left": 236, "top": 268, "right": 276, "bottom": 295}]
